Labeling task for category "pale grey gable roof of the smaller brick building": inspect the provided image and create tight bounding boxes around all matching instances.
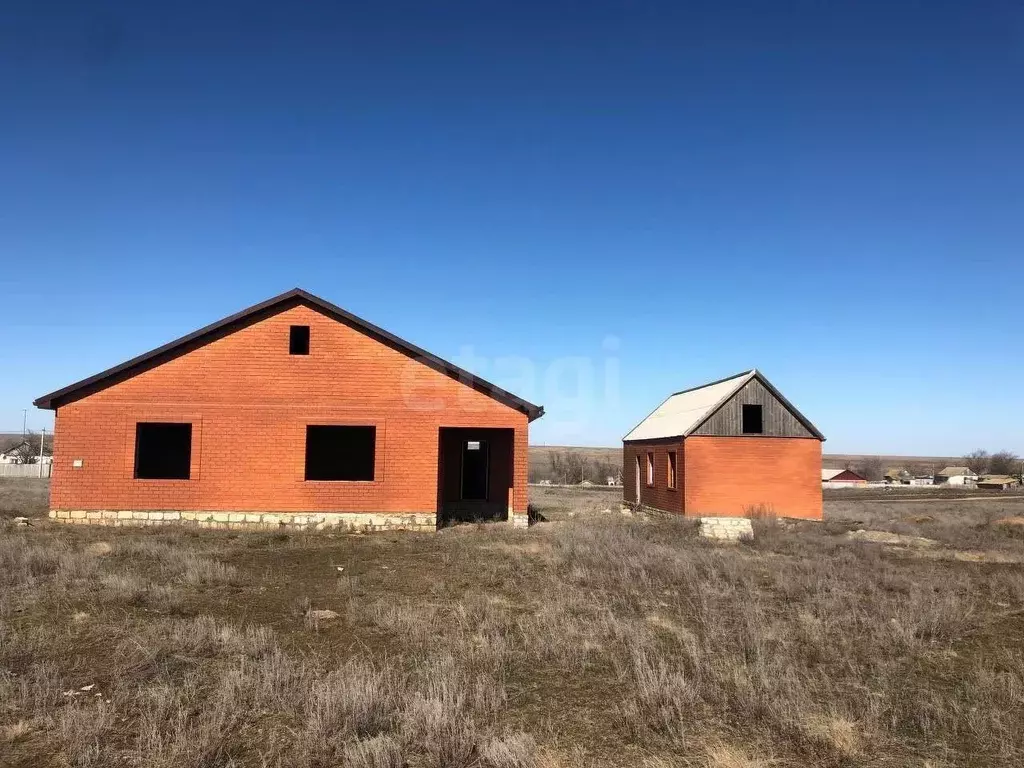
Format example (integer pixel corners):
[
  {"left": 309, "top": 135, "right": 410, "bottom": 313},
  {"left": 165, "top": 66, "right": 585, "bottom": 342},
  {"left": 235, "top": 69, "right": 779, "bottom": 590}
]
[{"left": 623, "top": 368, "right": 825, "bottom": 441}]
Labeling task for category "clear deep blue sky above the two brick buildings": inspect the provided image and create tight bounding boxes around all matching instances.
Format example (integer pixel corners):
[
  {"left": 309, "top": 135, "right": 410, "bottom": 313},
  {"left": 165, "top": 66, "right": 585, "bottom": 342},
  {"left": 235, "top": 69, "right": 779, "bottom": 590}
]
[{"left": 0, "top": 0, "right": 1024, "bottom": 455}]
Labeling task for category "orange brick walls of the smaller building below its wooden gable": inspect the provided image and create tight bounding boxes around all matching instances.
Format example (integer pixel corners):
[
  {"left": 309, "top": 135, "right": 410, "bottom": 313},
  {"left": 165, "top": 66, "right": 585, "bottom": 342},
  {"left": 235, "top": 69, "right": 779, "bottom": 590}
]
[{"left": 623, "top": 435, "right": 822, "bottom": 520}]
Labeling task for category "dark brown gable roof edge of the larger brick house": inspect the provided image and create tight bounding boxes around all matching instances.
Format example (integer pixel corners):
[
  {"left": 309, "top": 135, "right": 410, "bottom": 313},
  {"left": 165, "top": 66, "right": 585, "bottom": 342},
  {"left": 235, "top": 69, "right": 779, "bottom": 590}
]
[{"left": 34, "top": 288, "right": 544, "bottom": 421}]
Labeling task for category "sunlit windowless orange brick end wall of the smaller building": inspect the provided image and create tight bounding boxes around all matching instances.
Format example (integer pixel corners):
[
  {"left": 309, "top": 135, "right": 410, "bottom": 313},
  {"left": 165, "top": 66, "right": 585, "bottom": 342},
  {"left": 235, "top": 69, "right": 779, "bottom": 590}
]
[{"left": 684, "top": 436, "right": 821, "bottom": 519}]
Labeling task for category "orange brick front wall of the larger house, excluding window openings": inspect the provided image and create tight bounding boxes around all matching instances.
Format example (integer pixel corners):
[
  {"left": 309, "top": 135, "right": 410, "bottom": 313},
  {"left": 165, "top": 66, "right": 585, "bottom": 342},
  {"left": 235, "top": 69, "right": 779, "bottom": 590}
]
[{"left": 50, "top": 305, "right": 527, "bottom": 524}]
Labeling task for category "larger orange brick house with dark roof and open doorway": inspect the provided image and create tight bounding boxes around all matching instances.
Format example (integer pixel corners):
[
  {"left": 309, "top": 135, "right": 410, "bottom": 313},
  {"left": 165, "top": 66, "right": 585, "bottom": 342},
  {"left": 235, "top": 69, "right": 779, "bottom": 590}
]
[{"left": 36, "top": 289, "right": 544, "bottom": 529}]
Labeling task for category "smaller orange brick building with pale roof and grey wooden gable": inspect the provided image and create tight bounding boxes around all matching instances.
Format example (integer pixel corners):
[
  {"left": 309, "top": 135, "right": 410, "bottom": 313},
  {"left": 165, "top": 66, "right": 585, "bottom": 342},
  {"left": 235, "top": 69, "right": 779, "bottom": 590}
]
[{"left": 623, "top": 371, "right": 824, "bottom": 519}]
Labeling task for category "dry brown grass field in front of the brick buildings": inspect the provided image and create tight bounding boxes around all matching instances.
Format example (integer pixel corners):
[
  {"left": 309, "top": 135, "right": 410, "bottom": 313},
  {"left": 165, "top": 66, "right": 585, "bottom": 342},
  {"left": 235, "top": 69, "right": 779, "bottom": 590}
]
[{"left": 0, "top": 480, "right": 1024, "bottom": 768}]
